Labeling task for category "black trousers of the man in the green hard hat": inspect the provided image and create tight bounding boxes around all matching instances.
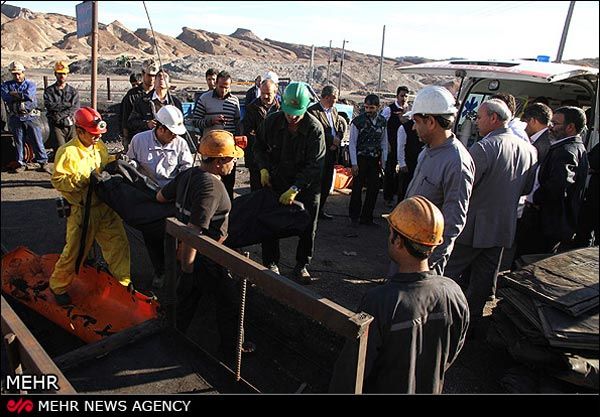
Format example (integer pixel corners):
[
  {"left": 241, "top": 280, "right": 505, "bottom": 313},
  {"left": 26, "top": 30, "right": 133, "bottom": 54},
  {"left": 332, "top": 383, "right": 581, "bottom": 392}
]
[{"left": 262, "top": 190, "right": 321, "bottom": 266}]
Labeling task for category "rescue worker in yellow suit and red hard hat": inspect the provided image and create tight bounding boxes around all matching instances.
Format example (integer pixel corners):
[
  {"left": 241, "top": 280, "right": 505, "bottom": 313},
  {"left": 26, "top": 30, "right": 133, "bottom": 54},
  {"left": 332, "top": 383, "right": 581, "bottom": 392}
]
[{"left": 50, "top": 107, "right": 131, "bottom": 305}]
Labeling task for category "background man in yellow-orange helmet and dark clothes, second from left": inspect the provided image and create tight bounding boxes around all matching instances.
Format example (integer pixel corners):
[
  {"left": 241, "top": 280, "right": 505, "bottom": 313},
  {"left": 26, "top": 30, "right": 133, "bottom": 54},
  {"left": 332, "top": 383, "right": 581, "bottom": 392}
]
[{"left": 44, "top": 61, "right": 79, "bottom": 151}]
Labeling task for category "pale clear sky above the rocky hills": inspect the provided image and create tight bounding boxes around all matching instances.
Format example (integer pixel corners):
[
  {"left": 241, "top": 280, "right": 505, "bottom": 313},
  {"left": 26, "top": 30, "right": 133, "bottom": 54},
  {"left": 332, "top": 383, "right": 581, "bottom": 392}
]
[{"left": 7, "top": 1, "right": 600, "bottom": 59}]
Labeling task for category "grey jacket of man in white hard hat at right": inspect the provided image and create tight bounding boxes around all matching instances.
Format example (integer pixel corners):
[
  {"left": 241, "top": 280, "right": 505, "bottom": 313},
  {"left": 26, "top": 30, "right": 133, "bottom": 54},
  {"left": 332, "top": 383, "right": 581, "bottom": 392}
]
[{"left": 406, "top": 134, "right": 475, "bottom": 274}]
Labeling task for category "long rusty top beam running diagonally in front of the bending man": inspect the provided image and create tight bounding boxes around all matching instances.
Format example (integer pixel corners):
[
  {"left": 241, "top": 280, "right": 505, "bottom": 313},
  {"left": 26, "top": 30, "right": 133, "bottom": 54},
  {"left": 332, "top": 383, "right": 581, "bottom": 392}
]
[{"left": 166, "top": 218, "right": 373, "bottom": 338}]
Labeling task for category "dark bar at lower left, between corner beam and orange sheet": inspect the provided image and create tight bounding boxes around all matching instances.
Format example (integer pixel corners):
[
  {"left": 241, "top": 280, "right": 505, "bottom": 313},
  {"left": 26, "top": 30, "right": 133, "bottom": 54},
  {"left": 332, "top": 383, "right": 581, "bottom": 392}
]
[{"left": 54, "top": 319, "right": 165, "bottom": 371}]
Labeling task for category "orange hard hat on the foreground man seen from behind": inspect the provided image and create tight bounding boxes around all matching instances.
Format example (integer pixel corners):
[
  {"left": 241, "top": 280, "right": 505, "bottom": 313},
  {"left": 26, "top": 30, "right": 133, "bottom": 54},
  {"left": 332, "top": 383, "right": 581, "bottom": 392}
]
[{"left": 388, "top": 195, "right": 444, "bottom": 246}]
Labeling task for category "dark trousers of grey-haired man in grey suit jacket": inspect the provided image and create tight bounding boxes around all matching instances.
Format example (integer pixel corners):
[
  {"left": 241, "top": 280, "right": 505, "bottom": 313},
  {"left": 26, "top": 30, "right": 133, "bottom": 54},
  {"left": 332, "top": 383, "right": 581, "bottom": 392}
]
[{"left": 444, "top": 243, "right": 504, "bottom": 320}]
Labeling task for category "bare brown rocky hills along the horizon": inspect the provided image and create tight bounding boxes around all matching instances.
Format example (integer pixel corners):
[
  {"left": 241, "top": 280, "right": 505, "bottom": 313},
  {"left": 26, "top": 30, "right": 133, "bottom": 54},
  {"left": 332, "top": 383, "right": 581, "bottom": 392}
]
[{"left": 1, "top": 4, "right": 598, "bottom": 91}]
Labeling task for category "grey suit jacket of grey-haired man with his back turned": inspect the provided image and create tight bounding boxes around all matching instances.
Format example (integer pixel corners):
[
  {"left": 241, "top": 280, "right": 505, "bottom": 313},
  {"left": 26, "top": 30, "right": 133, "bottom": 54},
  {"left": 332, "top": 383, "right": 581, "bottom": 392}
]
[{"left": 456, "top": 128, "right": 537, "bottom": 248}]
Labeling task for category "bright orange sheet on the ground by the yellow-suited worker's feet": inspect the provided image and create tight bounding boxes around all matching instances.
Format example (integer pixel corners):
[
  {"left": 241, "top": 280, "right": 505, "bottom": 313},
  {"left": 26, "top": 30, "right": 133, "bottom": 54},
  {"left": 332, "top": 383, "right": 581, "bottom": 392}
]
[{"left": 2, "top": 246, "right": 159, "bottom": 343}]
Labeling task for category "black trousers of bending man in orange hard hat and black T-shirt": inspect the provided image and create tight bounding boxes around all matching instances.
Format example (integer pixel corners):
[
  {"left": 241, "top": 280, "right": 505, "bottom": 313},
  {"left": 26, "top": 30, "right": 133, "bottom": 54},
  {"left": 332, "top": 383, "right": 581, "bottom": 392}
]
[{"left": 177, "top": 253, "right": 239, "bottom": 353}]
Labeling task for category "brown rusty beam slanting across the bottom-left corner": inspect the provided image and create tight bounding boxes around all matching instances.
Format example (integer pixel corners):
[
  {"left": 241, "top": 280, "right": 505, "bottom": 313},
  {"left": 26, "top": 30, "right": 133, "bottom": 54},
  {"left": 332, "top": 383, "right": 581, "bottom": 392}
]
[{"left": 1, "top": 296, "right": 76, "bottom": 394}]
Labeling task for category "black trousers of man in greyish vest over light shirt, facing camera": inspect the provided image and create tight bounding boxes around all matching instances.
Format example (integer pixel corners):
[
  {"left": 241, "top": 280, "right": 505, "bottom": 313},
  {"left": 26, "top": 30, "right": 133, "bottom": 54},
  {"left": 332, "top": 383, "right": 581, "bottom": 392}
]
[{"left": 349, "top": 155, "right": 379, "bottom": 222}]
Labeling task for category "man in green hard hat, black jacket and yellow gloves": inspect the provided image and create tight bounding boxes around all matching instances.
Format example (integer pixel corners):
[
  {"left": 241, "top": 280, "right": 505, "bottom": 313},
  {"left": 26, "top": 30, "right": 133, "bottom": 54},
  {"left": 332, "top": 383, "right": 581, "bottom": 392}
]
[{"left": 254, "top": 82, "right": 325, "bottom": 284}]
